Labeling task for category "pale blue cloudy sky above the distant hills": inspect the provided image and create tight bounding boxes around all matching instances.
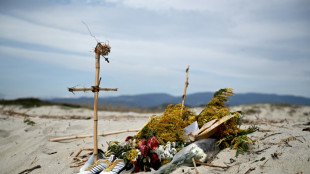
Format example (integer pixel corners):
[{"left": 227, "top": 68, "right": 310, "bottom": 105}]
[{"left": 0, "top": 0, "right": 310, "bottom": 99}]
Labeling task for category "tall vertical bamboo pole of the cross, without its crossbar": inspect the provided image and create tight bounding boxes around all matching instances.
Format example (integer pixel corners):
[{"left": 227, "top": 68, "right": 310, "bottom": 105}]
[{"left": 94, "top": 52, "right": 100, "bottom": 162}]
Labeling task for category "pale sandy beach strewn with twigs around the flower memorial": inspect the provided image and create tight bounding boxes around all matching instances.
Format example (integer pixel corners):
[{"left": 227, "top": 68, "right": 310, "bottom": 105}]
[{"left": 0, "top": 104, "right": 310, "bottom": 174}]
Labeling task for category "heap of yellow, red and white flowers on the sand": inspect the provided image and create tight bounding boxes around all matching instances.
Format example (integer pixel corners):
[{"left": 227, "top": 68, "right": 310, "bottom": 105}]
[{"left": 107, "top": 88, "right": 256, "bottom": 172}]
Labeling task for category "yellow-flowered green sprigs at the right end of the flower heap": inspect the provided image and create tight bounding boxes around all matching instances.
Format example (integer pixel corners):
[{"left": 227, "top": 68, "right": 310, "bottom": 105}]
[{"left": 198, "top": 88, "right": 258, "bottom": 156}]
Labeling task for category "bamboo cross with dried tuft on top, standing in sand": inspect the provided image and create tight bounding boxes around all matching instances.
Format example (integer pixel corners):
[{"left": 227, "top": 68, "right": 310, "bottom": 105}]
[{"left": 68, "top": 42, "right": 117, "bottom": 162}]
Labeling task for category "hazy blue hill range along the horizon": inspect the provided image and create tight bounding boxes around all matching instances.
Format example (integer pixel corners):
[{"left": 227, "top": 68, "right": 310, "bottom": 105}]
[{"left": 49, "top": 92, "right": 310, "bottom": 108}]
